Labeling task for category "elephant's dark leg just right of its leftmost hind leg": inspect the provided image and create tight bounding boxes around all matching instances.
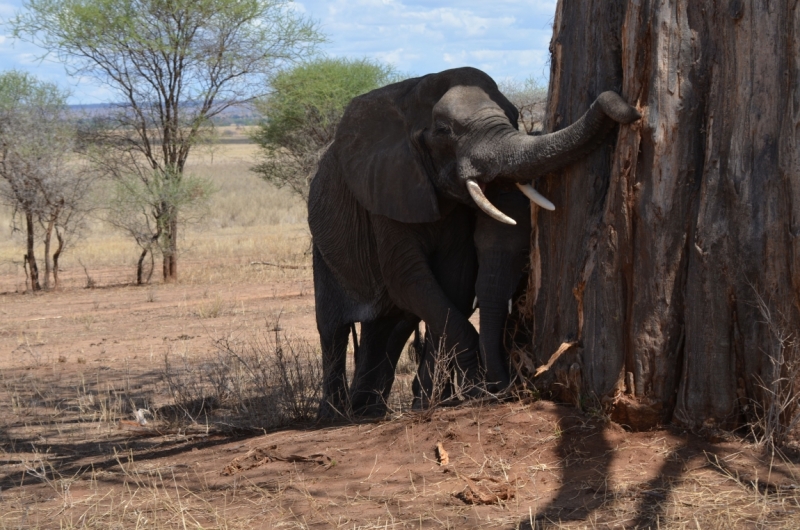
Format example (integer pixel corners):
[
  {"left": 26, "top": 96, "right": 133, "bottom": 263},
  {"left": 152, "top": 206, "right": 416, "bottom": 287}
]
[{"left": 351, "top": 316, "right": 419, "bottom": 416}]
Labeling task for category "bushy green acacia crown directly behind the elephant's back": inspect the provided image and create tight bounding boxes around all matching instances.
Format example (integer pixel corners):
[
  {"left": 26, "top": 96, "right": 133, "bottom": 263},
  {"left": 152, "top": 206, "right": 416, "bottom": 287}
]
[{"left": 253, "top": 58, "right": 400, "bottom": 198}]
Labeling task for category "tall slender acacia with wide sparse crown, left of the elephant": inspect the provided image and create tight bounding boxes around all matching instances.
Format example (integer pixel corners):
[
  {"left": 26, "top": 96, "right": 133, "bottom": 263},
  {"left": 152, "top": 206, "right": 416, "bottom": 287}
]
[{"left": 11, "top": 0, "right": 321, "bottom": 281}]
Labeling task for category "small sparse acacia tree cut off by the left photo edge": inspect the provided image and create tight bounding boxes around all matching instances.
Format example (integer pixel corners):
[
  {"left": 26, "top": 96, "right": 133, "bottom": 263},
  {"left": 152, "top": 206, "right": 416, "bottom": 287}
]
[{"left": 0, "top": 71, "right": 93, "bottom": 291}]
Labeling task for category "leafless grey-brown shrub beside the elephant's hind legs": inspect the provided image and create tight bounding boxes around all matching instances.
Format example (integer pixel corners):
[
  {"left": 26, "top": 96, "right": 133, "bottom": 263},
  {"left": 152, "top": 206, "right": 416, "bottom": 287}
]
[{"left": 162, "top": 324, "right": 322, "bottom": 430}]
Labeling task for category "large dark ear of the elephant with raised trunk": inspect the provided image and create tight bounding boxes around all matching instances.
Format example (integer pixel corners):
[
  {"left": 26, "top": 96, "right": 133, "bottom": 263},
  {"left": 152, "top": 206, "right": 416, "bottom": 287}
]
[{"left": 335, "top": 79, "right": 439, "bottom": 223}]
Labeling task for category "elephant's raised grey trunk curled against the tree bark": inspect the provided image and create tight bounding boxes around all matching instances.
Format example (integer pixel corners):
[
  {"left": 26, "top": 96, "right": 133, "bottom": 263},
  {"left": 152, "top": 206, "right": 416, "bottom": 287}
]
[{"left": 471, "top": 92, "right": 641, "bottom": 182}]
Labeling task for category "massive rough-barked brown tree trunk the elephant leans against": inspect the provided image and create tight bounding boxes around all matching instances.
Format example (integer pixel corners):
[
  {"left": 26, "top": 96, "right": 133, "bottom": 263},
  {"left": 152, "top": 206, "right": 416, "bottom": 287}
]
[{"left": 527, "top": 0, "right": 800, "bottom": 428}]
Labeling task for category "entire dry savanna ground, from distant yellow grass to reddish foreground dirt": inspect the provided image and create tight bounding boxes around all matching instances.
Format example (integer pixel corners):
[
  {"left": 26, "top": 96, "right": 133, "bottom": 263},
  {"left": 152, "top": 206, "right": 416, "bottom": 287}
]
[{"left": 0, "top": 128, "right": 800, "bottom": 529}]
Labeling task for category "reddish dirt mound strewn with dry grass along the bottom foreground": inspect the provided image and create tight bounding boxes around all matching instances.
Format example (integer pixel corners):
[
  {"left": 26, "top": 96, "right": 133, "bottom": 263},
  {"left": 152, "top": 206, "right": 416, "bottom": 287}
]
[{"left": 0, "top": 378, "right": 800, "bottom": 529}]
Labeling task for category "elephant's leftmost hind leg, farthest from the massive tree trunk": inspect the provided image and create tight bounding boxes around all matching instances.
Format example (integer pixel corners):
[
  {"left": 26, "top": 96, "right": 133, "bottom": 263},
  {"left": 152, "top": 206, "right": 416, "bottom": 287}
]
[{"left": 313, "top": 242, "right": 352, "bottom": 419}]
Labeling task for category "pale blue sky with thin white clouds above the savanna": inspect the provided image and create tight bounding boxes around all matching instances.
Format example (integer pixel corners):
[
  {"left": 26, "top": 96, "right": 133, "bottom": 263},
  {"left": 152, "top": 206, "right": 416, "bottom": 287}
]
[{"left": 0, "top": 0, "right": 556, "bottom": 103}]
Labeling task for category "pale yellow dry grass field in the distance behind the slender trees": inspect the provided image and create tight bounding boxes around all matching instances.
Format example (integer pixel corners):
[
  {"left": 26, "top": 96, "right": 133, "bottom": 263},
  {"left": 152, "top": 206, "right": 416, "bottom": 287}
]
[{"left": 0, "top": 128, "right": 310, "bottom": 292}]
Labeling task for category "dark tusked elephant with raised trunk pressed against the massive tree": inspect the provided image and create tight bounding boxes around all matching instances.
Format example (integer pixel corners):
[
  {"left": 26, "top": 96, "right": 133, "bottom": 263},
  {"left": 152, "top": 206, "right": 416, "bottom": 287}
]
[{"left": 308, "top": 67, "right": 640, "bottom": 418}]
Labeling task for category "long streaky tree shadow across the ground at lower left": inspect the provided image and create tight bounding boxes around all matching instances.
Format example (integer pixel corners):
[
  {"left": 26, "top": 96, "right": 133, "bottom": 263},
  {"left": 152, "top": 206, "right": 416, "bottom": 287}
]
[{"left": 0, "top": 364, "right": 374, "bottom": 492}]
